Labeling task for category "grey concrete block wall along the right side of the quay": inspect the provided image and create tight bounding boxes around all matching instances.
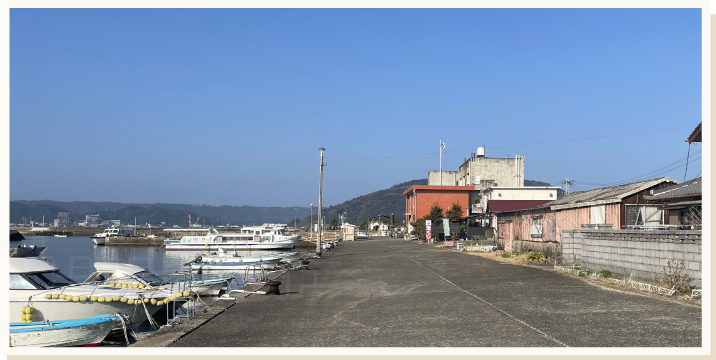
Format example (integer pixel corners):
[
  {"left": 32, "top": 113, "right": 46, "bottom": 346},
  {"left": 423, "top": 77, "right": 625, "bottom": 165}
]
[{"left": 562, "top": 230, "right": 702, "bottom": 287}]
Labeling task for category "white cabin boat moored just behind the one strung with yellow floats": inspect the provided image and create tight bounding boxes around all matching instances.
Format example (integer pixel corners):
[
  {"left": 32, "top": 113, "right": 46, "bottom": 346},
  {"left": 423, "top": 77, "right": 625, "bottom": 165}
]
[{"left": 84, "top": 262, "right": 234, "bottom": 296}]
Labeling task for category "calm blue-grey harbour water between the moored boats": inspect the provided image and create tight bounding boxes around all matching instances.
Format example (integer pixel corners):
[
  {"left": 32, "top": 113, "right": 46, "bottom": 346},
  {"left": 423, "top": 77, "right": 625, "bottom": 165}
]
[{"left": 10, "top": 235, "right": 305, "bottom": 289}]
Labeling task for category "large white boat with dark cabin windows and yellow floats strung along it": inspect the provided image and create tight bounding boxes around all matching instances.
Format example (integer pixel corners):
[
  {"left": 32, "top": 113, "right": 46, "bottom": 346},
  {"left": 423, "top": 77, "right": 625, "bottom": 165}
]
[{"left": 8, "top": 257, "right": 176, "bottom": 327}]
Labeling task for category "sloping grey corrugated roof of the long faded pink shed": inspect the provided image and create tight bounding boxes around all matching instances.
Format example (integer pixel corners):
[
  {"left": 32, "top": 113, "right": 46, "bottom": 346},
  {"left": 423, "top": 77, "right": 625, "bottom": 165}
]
[{"left": 539, "top": 176, "right": 679, "bottom": 210}]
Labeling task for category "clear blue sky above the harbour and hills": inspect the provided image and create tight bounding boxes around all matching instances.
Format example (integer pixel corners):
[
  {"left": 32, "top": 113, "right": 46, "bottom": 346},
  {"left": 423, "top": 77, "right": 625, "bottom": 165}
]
[{"left": 10, "top": 9, "right": 702, "bottom": 206}]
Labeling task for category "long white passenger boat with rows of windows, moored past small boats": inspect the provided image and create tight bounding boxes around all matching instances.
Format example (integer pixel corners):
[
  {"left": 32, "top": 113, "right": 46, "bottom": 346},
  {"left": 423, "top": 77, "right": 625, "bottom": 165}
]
[{"left": 164, "top": 224, "right": 301, "bottom": 251}]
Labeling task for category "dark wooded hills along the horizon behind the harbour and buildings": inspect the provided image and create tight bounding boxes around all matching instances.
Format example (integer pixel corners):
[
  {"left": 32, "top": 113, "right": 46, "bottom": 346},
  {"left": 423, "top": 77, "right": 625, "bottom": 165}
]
[{"left": 10, "top": 179, "right": 562, "bottom": 227}]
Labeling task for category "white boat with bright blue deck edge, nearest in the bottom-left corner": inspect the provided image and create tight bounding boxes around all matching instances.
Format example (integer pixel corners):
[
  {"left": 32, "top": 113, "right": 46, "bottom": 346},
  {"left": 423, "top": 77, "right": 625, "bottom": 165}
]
[{"left": 10, "top": 314, "right": 124, "bottom": 347}]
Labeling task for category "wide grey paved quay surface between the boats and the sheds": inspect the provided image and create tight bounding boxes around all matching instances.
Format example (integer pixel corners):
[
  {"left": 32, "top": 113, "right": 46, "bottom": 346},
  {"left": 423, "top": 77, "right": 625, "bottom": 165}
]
[{"left": 135, "top": 238, "right": 702, "bottom": 347}]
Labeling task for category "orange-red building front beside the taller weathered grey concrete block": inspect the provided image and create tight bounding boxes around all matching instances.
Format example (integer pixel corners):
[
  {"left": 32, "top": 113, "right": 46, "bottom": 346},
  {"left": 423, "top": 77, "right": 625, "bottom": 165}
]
[{"left": 403, "top": 185, "right": 475, "bottom": 223}]
